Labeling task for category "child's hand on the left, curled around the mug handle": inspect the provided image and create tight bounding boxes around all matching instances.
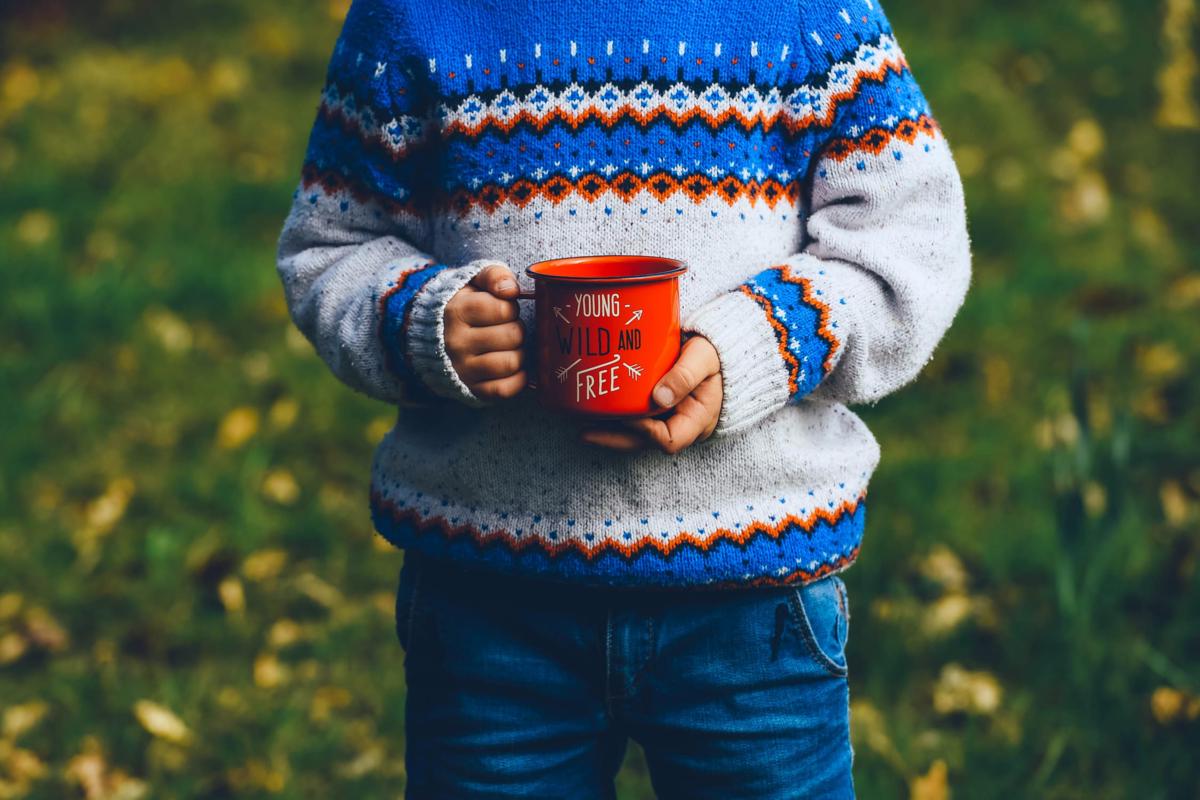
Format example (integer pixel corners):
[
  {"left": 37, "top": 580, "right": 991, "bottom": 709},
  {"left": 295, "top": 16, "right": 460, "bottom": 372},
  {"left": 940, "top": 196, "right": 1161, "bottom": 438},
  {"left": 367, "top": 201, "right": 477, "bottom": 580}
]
[{"left": 443, "top": 265, "right": 526, "bottom": 399}]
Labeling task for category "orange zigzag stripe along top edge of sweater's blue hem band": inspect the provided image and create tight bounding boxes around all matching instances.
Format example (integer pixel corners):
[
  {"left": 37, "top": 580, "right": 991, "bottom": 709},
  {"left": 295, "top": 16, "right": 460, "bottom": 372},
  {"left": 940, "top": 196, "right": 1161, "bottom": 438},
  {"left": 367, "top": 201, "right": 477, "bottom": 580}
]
[{"left": 371, "top": 491, "right": 866, "bottom": 561}]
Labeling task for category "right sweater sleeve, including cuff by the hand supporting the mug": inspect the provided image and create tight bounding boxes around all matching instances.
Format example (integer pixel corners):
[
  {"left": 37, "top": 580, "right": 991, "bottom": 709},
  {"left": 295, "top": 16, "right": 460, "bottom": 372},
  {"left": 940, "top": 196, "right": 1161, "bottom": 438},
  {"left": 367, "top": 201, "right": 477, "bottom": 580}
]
[{"left": 684, "top": 0, "right": 971, "bottom": 435}]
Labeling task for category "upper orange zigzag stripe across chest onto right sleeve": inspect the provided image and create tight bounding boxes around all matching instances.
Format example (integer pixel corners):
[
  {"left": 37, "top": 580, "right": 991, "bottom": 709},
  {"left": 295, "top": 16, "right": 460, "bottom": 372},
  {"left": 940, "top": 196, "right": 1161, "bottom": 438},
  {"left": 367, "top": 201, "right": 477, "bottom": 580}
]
[{"left": 442, "top": 56, "right": 908, "bottom": 138}]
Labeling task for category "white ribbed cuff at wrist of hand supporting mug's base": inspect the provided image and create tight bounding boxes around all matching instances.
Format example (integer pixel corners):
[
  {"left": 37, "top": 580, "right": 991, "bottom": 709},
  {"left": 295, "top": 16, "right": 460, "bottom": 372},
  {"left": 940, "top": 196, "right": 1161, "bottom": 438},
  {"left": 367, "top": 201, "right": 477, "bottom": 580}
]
[{"left": 682, "top": 291, "right": 788, "bottom": 437}]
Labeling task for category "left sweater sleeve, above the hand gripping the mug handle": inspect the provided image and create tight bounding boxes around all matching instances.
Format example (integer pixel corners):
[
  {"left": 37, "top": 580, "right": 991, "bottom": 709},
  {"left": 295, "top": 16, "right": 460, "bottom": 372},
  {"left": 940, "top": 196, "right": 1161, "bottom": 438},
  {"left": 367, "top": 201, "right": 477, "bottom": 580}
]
[{"left": 277, "top": 0, "right": 500, "bottom": 405}]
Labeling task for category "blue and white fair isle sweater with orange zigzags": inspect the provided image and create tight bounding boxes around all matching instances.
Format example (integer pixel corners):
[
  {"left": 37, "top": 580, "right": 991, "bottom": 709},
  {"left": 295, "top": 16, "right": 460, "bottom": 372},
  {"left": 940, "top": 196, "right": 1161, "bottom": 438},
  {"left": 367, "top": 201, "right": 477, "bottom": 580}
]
[{"left": 278, "top": 0, "right": 971, "bottom": 589}]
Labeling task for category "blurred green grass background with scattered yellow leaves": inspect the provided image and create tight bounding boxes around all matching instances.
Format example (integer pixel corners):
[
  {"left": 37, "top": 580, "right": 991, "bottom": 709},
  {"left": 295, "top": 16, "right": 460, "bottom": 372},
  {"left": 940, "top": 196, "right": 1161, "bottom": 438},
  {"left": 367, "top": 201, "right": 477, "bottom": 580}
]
[{"left": 0, "top": 0, "right": 1200, "bottom": 800}]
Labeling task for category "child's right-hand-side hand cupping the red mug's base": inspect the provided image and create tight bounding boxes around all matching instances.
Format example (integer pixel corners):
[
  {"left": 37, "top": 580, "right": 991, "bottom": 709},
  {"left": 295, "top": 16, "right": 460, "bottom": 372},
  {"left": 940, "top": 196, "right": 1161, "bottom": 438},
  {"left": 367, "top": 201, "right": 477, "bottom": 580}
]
[{"left": 581, "top": 336, "right": 725, "bottom": 453}]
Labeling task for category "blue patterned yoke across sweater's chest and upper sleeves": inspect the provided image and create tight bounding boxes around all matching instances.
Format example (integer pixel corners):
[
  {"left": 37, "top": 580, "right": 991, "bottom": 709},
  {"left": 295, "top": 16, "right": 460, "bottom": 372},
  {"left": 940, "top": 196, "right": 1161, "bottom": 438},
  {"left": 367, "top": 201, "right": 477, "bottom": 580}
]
[{"left": 297, "top": 0, "right": 930, "bottom": 216}]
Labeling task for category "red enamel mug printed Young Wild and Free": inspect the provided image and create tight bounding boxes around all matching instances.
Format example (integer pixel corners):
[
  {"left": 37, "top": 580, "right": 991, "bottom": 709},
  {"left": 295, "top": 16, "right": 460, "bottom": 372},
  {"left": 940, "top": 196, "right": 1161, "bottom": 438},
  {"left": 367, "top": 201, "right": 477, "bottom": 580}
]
[{"left": 521, "top": 255, "right": 688, "bottom": 417}]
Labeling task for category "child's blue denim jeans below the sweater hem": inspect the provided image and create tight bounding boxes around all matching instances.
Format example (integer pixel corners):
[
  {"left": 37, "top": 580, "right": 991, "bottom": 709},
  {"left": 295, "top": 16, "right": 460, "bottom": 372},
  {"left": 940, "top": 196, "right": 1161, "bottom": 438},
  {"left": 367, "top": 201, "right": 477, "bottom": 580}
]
[{"left": 396, "top": 549, "right": 854, "bottom": 800}]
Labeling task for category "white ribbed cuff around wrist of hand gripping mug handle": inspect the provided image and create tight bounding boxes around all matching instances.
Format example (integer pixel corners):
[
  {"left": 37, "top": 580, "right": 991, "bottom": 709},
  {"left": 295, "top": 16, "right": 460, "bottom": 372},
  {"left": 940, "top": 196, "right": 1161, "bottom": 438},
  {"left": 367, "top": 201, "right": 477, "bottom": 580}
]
[{"left": 406, "top": 259, "right": 504, "bottom": 408}]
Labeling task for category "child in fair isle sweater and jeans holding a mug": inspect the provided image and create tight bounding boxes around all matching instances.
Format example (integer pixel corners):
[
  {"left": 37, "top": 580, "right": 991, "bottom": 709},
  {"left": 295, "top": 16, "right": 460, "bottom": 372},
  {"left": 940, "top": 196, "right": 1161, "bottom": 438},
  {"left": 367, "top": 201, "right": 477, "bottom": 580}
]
[{"left": 278, "top": 0, "right": 970, "bottom": 800}]
